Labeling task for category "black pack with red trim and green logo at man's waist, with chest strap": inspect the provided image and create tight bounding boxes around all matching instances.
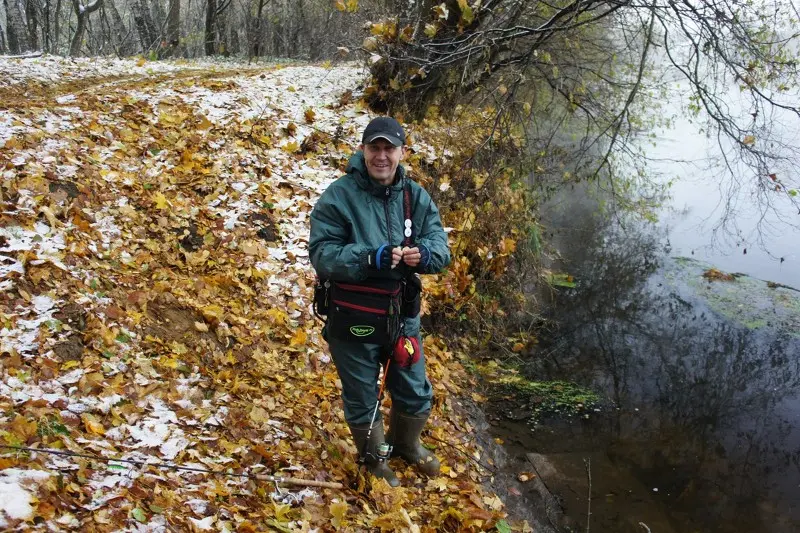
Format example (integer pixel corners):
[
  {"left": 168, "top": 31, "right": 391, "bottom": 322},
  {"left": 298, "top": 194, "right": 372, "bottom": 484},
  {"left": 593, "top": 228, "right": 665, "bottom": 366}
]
[{"left": 314, "top": 179, "right": 422, "bottom": 346}]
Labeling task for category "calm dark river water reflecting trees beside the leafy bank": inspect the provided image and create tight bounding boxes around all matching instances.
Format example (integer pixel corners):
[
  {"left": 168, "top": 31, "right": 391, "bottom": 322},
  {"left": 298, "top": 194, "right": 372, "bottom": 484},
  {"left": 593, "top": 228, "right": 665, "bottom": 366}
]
[{"left": 492, "top": 81, "right": 800, "bottom": 533}]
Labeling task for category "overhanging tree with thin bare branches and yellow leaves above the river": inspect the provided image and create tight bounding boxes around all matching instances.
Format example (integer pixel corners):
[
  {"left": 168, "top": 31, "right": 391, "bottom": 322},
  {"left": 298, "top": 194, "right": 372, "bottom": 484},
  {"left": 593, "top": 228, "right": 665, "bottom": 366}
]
[{"left": 364, "top": 0, "right": 800, "bottom": 236}]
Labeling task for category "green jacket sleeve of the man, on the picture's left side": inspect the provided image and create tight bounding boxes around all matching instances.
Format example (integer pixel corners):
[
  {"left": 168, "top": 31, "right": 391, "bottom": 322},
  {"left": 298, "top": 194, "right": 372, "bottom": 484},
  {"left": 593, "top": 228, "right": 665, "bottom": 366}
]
[{"left": 308, "top": 185, "right": 370, "bottom": 281}]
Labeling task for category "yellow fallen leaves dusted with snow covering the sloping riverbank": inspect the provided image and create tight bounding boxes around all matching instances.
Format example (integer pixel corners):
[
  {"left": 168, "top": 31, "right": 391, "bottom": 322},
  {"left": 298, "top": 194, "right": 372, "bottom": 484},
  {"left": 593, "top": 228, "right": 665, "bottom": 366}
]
[{"left": 0, "top": 56, "right": 505, "bottom": 531}]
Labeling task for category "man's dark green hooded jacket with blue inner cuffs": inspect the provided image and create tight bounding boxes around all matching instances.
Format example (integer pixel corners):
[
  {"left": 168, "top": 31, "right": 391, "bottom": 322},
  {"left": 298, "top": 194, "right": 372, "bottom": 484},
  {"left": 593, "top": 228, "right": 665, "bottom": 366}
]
[{"left": 308, "top": 152, "right": 450, "bottom": 334}]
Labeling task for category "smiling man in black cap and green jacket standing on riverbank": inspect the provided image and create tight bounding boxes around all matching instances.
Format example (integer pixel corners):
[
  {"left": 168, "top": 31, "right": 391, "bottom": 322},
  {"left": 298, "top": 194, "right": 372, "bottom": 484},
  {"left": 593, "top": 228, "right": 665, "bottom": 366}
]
[{"left": 309, "top": 117, "right": 450, "bottom": 486}]
